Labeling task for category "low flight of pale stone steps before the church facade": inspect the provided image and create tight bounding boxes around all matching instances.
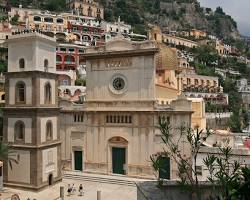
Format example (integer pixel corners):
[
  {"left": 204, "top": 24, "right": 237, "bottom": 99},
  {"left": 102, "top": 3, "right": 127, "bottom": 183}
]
[{"left": 64, "top": 174, "right": 139, "bottom": 187}]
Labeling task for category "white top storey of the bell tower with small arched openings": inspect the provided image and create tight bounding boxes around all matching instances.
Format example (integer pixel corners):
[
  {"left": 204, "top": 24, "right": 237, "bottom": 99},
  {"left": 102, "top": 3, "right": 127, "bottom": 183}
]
[{"left": 7, "top": 31, "right": 56, "bottom": 73}]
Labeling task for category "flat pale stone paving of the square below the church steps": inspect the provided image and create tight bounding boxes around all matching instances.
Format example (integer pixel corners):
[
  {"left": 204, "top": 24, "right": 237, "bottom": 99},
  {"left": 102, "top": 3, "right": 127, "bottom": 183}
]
[{"left": 0, "top": 174, "right": 137, "bottom": 200}]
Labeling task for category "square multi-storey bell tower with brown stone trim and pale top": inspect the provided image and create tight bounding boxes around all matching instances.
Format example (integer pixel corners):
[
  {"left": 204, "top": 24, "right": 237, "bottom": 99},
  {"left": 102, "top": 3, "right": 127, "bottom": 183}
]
[{"left": 4, "top": 32, "right": 61, "bottom": 190}]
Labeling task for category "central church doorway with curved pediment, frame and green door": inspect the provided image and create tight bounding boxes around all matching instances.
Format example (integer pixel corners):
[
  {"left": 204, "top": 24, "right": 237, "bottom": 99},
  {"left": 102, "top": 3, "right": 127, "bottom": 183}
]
[{"left": 109, "top": 137, "right": 128, "bottom": 174}]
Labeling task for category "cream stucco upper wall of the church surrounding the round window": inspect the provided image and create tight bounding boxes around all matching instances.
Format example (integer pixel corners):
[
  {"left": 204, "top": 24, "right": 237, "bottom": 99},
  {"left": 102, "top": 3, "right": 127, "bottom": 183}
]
[{"left": 86, "top": 56, "right": 155, "bottom": 101}]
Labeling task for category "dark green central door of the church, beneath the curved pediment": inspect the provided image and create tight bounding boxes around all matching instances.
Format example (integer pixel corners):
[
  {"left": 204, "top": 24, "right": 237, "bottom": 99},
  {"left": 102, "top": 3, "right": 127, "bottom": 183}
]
[{"left": 112, "top": 147, "right": 126, "bottom": 174}]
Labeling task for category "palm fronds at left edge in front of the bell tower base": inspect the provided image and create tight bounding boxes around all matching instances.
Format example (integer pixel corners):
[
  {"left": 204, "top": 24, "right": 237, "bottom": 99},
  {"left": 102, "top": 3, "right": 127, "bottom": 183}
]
[{"left": 0, "top": 141, "right": 19, "bottom": 169}]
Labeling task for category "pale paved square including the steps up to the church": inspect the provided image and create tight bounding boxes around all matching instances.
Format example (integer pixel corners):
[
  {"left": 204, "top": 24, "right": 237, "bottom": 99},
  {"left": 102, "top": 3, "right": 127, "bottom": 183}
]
[{"left": 0, "top": 172, "right": 153, "bottom": 200}]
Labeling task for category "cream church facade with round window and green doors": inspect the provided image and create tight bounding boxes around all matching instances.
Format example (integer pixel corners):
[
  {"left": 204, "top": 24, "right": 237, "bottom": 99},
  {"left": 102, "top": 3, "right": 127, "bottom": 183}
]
[{"left": 60, "top": 35, "right": 192, "bottom": 179}]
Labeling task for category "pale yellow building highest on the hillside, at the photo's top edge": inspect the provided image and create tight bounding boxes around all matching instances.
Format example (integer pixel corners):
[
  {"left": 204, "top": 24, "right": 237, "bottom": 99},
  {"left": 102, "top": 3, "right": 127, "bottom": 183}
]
[{"left": 67, "top": 0, "right": 104, "bottom": 19}]
